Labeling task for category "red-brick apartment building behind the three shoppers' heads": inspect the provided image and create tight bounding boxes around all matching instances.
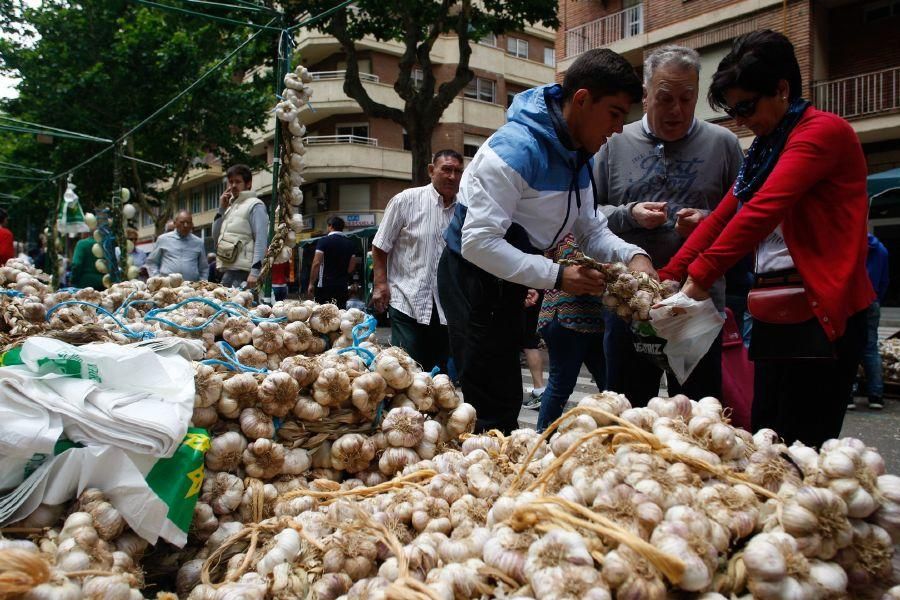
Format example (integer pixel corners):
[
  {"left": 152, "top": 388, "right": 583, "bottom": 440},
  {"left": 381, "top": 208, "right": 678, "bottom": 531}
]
[{"left": 556, "top": 0, "right": 900, "bottom": 166}]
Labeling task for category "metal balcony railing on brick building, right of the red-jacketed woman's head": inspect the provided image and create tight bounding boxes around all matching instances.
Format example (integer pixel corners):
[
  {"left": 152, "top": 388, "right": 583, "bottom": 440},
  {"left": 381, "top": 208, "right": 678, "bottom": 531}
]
[{"left": 813, "top": 67, "right": 900, "bottom": 118}]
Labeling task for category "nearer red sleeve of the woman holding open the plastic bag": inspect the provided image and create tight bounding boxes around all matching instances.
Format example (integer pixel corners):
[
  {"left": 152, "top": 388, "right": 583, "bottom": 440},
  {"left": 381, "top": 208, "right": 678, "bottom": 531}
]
[{"left": 688, "top": 113, "right": 856, "bottom": 289}]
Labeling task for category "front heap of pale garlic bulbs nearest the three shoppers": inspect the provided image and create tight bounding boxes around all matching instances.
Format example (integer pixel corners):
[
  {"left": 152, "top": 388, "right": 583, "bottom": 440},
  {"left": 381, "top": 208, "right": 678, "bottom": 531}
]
[{"left": 163, "top": 392, "right": 900, "bottom": 600}]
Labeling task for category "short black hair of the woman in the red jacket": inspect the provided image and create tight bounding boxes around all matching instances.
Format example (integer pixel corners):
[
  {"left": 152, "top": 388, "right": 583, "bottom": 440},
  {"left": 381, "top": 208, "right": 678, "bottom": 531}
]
[{"left": 707, "top": 29, "right": 803, "bottom": 110}]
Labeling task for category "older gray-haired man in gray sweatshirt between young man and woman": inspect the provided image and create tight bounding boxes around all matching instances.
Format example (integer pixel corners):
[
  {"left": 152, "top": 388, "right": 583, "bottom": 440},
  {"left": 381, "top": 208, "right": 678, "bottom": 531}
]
[{"left": 594, "top": 46, "right": 743, "bottom": 406}]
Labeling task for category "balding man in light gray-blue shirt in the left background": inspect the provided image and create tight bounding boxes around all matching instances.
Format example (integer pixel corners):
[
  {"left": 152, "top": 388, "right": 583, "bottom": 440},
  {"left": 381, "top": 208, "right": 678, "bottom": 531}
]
[{"left": 144, "top": 210, "right": 209, "bottom": 281}]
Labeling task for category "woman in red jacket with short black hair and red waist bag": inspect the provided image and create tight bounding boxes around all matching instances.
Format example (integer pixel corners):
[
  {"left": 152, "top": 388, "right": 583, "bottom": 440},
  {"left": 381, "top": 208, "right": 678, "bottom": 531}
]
[{"left": 659, "top": 30, "right": 874, "bottom": 446}]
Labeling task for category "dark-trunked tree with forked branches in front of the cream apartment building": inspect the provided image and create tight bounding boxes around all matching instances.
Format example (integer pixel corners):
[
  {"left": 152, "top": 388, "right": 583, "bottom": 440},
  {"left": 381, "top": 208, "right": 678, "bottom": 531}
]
[{"left": 280, "top": 0, "right": 558, "bottom": 184}]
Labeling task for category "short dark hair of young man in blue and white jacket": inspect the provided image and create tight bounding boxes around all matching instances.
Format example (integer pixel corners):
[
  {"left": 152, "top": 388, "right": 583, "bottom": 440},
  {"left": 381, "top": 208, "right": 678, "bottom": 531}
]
[{"left": 562, "top": 48, "right": 643, "bottom": 102}]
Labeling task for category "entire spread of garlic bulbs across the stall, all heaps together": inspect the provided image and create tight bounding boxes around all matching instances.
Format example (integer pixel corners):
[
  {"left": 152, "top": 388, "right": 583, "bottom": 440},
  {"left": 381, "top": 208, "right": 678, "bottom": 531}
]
[{"left": 0, "top": 264, "right": 900, "bottom": 600}]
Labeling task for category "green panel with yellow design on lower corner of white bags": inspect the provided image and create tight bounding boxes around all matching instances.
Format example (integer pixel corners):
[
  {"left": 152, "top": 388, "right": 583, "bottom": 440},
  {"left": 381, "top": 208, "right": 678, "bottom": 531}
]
[{"left": 145, "top": 427, "right": 210, "bottom": 533}]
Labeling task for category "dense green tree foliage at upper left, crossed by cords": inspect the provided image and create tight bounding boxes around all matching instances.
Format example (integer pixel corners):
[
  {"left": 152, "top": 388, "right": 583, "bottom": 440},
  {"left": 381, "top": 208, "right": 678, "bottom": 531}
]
[{"left": 0, "top": 0, "right": 275, "bottom": 239}]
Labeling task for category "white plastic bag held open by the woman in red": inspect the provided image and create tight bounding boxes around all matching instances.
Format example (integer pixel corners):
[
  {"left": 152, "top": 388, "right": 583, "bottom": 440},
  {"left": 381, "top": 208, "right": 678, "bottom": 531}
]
[{"left": 650, "top": 292, "right": 725, "bottom": 383}]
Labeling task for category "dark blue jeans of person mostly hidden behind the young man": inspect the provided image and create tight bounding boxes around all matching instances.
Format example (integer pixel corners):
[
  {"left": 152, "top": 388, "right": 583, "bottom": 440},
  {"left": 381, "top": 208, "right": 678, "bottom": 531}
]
[{"left": 537, "top": 318, "right": 606, "bottom": 432}]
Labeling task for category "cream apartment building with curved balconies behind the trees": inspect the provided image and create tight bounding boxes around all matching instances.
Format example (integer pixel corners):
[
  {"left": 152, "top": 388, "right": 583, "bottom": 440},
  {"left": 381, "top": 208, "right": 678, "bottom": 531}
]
[{"left": 139, "top": 27, "right": 557, "bottom": 240}]
